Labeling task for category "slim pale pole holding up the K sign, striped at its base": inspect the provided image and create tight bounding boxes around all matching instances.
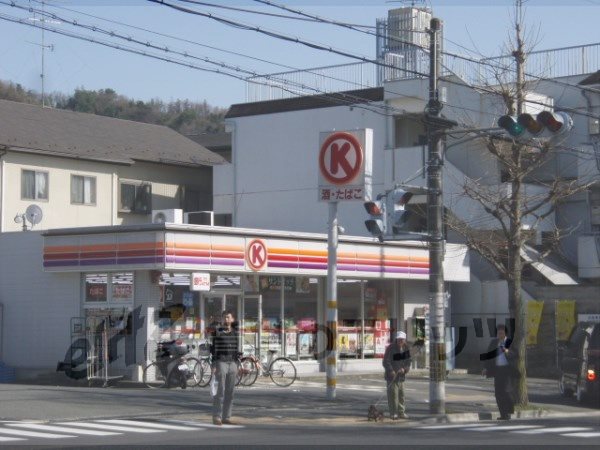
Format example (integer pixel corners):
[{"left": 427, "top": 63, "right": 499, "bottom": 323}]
[{"left": 325, "top": 202, "right": 338, "bottom": 400}]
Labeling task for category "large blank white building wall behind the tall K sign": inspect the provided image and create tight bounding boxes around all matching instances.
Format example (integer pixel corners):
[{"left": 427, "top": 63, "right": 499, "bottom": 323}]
[{"left": 227, "top": 105, "right": 386, "bottom": 236}]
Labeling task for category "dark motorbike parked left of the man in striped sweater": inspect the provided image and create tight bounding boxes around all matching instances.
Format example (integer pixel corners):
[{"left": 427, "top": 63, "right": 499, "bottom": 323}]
[{"left": 143, "top": 339, "right": 202, "bottom": 389}]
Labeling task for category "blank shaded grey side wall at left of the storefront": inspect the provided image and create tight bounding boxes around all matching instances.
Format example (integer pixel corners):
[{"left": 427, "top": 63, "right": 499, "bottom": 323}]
[{"left": 0, "top": 231, "right": 81, "bottom": 369}]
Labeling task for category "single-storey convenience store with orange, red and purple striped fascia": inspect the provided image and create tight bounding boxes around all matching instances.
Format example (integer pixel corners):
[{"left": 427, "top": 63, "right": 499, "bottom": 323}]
[{"left": 0, "top": 224, "right": 469, "bottom": 379}]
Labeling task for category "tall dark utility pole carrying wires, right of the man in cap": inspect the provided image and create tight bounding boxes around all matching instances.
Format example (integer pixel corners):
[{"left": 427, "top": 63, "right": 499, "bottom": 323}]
[{"left": 425, "top": 18, "right": 456, "bottom": 414}]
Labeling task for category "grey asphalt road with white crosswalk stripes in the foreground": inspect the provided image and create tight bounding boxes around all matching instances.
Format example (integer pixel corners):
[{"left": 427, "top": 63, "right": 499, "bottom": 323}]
[{"left": 0, "top": 375, "right": 600, "bottom": 448}]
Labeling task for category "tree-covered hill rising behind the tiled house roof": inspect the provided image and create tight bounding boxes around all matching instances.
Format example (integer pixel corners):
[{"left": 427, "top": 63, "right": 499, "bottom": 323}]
[{"left": 0, "top": 81, "right": 227, "bottom": 134}]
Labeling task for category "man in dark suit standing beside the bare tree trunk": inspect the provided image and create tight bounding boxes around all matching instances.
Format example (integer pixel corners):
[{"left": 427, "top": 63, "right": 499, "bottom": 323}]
[{"left": 480, "top": 325, "right": 518, "bottom": 420}]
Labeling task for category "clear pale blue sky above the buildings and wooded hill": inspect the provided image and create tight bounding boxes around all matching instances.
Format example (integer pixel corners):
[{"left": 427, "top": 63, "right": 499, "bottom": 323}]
[{"left": 0, "top": 0, "right": 600, "bottom": 108}]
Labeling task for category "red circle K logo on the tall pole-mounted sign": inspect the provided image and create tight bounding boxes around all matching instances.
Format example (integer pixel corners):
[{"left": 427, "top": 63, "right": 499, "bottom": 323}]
[{"left": 319, "top": 131, "right": 363, "bottom": 184}]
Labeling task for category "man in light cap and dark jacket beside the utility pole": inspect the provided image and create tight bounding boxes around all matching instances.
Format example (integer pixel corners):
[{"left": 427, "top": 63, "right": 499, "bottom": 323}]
[{"left": 383, "top": 331, "right": 410, "bottom": 420}]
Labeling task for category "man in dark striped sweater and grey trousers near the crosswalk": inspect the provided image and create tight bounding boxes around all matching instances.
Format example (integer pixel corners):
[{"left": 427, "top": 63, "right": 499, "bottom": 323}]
[{"left": 211, "top": 311, "right": 239, "bottom": 425}]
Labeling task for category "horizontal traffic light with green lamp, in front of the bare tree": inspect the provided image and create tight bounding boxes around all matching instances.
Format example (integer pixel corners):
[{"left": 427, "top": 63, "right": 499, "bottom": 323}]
[{"left": 498, "top": 111, "right": 573, "bottom": 138}]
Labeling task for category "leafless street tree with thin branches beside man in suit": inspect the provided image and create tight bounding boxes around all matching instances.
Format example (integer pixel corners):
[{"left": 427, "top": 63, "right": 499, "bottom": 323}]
[{"left": 446, "top": 0, "right": 597, "bottom": 405}]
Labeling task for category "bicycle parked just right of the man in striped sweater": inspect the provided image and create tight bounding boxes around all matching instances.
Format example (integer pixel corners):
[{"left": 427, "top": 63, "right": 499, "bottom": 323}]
[{"left": 238, "top": 350, "right": 296, "bottom": 387}]
